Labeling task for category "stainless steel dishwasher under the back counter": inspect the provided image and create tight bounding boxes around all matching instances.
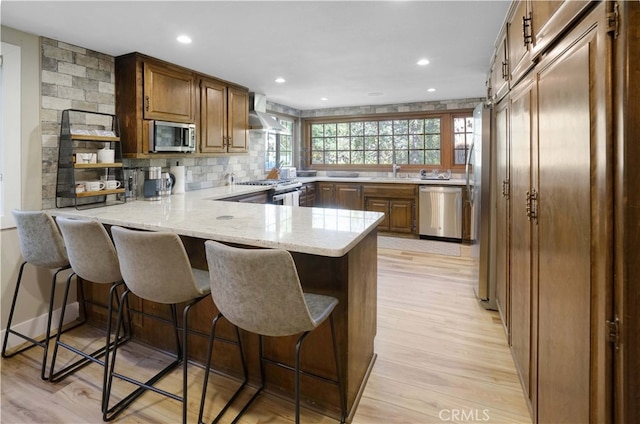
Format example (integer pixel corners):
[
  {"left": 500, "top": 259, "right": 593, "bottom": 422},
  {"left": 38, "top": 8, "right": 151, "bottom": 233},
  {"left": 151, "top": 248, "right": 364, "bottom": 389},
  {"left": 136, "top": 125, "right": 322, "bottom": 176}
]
[{"left": 418, "top": 186, "right": 462, "bottom": 240}]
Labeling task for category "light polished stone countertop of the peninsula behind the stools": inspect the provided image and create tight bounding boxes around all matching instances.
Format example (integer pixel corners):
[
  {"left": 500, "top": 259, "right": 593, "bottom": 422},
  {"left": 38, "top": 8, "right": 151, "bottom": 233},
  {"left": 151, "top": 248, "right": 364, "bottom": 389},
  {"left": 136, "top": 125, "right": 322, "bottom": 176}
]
[{"left": 48, "top": 185, "right": 384, "bottom": 257}]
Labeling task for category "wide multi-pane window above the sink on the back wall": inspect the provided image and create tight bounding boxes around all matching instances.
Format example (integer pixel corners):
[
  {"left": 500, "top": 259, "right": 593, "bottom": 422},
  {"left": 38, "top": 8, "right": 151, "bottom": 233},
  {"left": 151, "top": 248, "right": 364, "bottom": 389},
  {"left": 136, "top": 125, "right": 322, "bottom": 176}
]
[{"left": 305, "top": 112, "right": 473, "bottom": 170}]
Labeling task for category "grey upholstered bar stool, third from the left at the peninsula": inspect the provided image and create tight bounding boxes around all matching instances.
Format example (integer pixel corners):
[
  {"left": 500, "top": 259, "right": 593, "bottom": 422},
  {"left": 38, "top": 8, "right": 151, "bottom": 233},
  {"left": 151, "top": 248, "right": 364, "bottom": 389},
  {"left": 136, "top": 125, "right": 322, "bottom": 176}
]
[{"left": 102, "top": 226, "right": 210, "bottom": 423}]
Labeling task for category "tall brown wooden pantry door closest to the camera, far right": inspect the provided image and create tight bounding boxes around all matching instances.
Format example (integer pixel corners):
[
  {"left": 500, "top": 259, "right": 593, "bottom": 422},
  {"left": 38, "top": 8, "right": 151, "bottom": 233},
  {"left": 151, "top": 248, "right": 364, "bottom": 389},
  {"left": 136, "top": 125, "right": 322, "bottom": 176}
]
[{"left": 536, "top": 9, "right": 612, "bottom": 423}]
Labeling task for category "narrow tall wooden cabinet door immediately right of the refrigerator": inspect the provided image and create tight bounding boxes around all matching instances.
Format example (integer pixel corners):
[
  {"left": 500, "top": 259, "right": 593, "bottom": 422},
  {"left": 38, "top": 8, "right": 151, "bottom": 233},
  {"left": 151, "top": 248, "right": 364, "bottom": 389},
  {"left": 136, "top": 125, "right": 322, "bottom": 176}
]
[{"left": 494, "top": 99, "right": 511, "bottom": 328}]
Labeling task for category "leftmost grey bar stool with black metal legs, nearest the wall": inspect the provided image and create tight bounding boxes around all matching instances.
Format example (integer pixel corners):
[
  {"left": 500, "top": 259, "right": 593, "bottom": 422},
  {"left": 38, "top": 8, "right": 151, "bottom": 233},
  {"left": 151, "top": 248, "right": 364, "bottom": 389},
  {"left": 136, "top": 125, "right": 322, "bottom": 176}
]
[{"left": 2, "top": 210, "right": 71, "bottom": 380}]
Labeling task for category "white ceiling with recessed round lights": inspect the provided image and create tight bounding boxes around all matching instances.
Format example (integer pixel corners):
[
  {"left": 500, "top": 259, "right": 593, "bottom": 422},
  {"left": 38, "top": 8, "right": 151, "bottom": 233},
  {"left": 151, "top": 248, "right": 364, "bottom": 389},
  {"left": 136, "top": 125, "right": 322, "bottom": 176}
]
[{"left": 0, "top": 0, "right": 509, "bottom": 110}]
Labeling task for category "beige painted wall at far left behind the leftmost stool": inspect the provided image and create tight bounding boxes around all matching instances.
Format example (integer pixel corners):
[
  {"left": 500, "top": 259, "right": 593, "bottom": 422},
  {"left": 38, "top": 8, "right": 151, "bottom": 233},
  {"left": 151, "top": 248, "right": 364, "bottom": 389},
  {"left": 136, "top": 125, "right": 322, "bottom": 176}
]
[{"left": 0, "top": 26, "right": 73, "bottom": 343}]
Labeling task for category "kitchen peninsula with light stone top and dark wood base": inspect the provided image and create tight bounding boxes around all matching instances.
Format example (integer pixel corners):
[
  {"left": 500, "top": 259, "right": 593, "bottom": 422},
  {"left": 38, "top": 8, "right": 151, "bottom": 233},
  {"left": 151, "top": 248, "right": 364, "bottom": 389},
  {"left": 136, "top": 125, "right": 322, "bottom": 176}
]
[{"left": 49, "top": 190, "right": 383, "bottom": 418}]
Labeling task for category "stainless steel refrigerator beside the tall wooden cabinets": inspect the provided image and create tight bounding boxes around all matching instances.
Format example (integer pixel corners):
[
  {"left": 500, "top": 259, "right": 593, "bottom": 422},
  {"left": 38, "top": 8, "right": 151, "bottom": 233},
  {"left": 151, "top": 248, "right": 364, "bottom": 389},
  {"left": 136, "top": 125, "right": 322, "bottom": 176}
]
[{"left": 466, "top": 104, "right": 497, "bottom": 310}]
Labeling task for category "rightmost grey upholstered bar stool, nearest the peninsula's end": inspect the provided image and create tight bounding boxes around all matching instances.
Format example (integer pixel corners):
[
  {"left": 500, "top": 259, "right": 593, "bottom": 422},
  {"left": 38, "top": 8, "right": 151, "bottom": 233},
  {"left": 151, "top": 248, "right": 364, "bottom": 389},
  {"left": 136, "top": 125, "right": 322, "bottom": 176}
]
[{"left": 198, "top": 240, "right": 346, "bottom": 423}]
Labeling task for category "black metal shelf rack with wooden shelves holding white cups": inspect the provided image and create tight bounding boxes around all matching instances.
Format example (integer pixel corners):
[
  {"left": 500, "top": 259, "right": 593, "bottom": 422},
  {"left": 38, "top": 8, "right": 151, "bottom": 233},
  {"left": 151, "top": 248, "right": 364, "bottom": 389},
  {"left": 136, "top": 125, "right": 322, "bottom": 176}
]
[{"left": 56, "top": 109, "right": 125, "bottom": 209}]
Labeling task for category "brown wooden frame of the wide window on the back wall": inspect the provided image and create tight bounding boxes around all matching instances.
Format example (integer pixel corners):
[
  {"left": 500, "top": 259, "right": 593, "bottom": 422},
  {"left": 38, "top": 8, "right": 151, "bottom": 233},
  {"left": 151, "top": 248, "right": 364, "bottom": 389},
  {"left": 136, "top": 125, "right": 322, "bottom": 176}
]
[{"left": 302, "top": 109, "right": 473, "bottom": 172}]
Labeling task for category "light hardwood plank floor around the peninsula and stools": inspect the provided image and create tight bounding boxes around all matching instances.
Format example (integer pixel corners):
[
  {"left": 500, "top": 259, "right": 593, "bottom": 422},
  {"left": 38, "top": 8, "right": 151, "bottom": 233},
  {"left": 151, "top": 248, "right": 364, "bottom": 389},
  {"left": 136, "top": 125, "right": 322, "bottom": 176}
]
[{"left": 0, "top": 245, "right": 531, "bottom": 424}]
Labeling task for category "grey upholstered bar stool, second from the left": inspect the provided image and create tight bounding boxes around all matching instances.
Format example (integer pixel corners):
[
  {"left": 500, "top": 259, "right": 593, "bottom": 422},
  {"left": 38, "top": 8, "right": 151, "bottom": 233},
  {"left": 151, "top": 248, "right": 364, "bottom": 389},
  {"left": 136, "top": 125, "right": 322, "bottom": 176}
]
[{"left": 49, "top": 217, "right": 131, "bottom": 382}]
